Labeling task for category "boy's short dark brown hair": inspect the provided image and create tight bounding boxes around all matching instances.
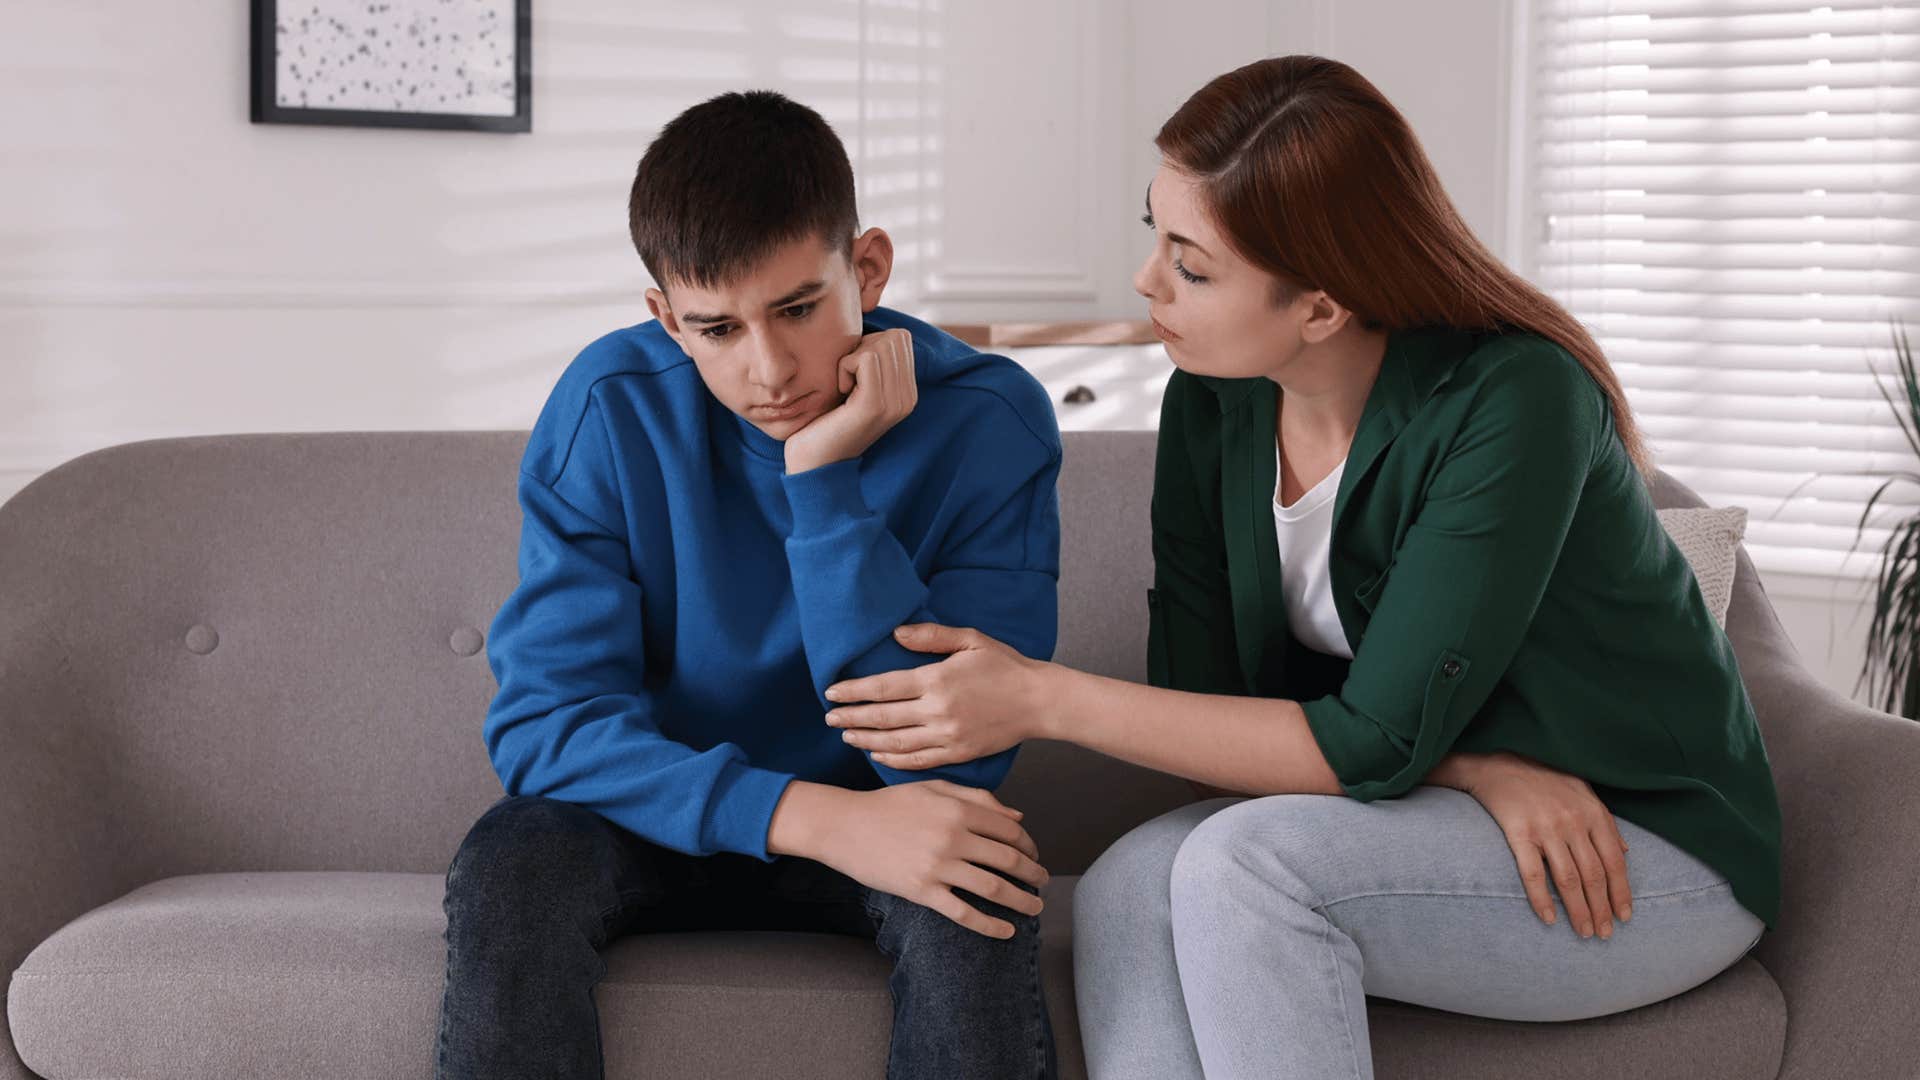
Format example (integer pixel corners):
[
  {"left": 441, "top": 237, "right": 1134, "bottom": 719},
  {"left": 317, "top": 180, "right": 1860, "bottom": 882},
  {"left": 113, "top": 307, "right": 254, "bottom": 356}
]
[{"left": 626, "top": 90, "right": 858, "bottom": 288}]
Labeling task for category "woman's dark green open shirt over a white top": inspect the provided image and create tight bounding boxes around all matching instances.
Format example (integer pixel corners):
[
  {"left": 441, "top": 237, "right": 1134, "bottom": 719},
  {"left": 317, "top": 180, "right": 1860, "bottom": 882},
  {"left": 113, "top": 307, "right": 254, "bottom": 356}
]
[{"left": 1148, "top": 329, "right": 1780, "bottom": 926}]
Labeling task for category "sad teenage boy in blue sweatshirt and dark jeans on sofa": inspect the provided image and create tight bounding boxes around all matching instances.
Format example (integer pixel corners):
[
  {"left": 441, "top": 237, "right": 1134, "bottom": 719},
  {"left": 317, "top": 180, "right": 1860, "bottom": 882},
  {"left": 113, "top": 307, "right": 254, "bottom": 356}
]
[{"left": 438, "top": 92, "right": 1060, "bottom": 1080}]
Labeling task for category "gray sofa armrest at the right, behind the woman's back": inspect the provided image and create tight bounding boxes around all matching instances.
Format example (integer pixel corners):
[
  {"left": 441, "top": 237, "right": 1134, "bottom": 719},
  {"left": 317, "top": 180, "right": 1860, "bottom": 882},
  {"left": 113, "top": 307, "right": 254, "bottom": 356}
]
[{"left": 1743, "top": 645, "right": 1920, "bottom": 1080}]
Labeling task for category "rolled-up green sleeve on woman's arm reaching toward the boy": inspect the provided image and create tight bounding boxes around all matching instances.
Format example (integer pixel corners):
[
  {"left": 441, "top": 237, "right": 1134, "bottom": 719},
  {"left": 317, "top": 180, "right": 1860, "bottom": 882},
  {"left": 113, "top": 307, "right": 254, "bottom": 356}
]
[{"left": 1300, "top": 338, "right": 1611, "bottom": 801}]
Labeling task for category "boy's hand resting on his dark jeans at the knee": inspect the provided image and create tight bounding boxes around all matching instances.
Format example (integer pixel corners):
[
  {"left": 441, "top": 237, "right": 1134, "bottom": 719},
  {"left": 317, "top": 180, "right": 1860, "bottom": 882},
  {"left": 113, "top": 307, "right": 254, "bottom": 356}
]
[{"left": 768, "top": 780, "right": 1050, "bottom": 938}]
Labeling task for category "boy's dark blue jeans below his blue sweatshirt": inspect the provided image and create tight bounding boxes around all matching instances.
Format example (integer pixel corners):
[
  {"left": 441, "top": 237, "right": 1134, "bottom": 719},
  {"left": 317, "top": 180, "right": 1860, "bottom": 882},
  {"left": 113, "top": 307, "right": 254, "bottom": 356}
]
[{"left": 438, "top": 796, "right": 1054, "bottom": 1080}]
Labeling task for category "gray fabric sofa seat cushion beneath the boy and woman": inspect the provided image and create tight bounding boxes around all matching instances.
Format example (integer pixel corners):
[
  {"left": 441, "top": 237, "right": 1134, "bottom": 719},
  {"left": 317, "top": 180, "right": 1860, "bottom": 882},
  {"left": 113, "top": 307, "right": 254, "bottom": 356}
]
[{"left": 8, "top": 872, "right": 1786, "bottom": 1080}]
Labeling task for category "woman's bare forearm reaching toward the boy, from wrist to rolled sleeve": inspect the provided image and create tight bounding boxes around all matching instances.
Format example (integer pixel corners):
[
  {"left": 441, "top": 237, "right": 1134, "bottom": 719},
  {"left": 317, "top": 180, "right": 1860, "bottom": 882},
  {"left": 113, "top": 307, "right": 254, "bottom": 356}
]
[{"left": 1037, "top": 665, "right": 1342, "bottom": 796}]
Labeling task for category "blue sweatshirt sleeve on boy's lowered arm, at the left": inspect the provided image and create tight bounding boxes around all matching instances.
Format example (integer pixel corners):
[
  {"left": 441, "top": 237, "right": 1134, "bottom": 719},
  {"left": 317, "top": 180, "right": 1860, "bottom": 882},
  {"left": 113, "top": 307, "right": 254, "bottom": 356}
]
[{"left": 486, "top": 403, "right": 793, "bottom": 859}]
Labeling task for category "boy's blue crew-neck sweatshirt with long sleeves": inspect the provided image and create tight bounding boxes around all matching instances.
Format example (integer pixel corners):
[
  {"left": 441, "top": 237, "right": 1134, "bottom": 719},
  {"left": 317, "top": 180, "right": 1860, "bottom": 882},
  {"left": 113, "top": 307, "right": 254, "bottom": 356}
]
[{"left": 484, "top": 307, "right": 1060, "bottom": 859}]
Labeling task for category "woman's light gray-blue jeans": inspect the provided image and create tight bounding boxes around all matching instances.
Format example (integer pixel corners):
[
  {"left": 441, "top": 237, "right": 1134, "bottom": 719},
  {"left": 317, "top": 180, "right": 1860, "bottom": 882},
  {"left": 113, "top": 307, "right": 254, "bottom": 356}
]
[{"left": 1073, "top": 786, "right": 1763, "bottom": 1080}]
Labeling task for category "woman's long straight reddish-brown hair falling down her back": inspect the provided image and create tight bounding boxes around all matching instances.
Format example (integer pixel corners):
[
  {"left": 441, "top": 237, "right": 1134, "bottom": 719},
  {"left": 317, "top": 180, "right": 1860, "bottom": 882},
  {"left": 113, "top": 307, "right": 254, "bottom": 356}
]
[{"left": 1154, "top": 56, "right": 1653, "bottom": 477}]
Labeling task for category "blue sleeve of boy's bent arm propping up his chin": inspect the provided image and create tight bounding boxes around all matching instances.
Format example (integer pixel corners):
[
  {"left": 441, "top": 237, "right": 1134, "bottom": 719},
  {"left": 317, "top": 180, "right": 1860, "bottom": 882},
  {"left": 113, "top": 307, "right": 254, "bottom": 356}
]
[{"left": 785, "top": 398, "right": 1060, "bottom": 788}]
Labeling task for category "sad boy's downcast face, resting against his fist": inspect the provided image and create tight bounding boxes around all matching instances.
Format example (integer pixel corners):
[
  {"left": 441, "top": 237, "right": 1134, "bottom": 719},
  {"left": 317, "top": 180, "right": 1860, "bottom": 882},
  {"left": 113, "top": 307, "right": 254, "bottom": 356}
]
[{"left": 647, "top": 229, "right": 893, "bottom": 440}]
